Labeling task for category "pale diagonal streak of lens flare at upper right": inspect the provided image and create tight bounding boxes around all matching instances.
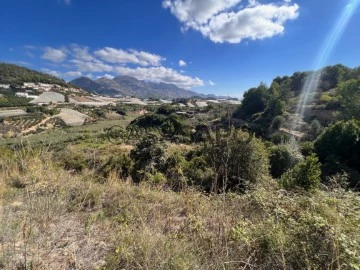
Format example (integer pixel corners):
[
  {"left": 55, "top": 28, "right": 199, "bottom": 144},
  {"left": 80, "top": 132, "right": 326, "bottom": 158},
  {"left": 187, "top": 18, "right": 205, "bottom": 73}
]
[{"left": 293, "top": 0, "right": 360, "bottom": 123}]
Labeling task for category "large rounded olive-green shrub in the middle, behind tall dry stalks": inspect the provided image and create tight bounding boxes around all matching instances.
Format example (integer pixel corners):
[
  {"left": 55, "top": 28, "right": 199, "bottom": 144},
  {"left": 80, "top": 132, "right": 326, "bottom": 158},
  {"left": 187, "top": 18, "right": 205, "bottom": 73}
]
[{"left": 202, "top": 129, "right": 269, "bottom": 192}]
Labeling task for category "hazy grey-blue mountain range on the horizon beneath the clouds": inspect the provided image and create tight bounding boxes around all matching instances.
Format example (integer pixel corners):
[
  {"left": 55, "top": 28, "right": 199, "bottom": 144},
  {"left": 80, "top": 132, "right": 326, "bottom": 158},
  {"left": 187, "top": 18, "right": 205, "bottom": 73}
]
[{"left": 70, "top": 76, "right": 206, "bottom": 99}]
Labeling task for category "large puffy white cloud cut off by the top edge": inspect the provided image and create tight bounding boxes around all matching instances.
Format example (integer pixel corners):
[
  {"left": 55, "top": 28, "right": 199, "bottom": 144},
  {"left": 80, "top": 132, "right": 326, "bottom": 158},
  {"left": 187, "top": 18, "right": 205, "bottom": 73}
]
[{"left": 163, "top": 0, "right": 299, "bottom": 43}]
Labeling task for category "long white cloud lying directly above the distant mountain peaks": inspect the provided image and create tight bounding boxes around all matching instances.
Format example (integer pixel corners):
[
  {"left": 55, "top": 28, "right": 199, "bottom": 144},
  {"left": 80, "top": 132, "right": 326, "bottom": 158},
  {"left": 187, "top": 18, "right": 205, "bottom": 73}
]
[{"left": 115, "top": 67, "right": 204, "bottom": 89}]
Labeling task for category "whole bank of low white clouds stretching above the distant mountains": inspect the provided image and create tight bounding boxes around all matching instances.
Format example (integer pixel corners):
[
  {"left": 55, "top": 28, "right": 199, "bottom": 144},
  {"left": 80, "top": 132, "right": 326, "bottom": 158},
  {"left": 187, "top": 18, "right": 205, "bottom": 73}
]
[{"left": 33, "top": 44, "right": 205, "bottom": 89}]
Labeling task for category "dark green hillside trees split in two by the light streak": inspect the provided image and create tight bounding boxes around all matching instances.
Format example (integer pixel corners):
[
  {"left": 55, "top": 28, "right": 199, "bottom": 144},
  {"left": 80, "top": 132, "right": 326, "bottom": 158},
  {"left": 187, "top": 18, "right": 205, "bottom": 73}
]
[{"left": 233, "top": 65, "right": 360, "bottom": 136}]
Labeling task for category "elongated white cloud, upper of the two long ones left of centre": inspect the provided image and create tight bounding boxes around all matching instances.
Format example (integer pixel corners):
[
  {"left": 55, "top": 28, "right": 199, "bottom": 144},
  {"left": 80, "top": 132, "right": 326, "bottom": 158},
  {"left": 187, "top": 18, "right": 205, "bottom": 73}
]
[{"left": 95, "top": 47, "right": 165, "bottom": 66}]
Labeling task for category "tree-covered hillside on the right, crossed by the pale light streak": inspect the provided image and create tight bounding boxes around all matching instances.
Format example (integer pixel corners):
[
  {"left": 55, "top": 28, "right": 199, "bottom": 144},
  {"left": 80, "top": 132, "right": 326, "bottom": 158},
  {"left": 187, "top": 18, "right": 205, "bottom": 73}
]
[{"left": 233, "top": 64, "right": 360, "bottom": 138}]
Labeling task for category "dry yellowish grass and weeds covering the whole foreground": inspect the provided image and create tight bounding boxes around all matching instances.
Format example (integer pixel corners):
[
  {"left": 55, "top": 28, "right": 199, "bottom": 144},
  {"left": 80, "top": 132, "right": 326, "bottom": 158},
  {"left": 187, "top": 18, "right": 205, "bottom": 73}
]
[{"left": 0, "top": 149, "right": 360, "bottom": 269}]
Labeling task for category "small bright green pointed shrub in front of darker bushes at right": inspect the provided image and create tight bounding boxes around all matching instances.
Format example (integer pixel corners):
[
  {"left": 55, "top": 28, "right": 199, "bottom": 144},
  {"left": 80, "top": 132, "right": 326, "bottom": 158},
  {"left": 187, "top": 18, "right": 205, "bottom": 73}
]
[{"left": 281, "top": 155, "right": 321, "bottom": 191}]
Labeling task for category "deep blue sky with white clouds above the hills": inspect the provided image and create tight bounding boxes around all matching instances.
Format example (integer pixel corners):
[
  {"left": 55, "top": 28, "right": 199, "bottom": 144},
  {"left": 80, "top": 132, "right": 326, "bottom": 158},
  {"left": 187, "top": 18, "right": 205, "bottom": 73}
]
[{"left": 0, "top": 0, "right": 360, "bottom": 97}]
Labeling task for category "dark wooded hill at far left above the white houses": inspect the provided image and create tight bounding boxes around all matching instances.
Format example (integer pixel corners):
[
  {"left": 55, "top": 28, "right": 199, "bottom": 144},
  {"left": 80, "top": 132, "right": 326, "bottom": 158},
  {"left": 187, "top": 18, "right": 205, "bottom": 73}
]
[{"left": 0, "top": 62, "right": 69, "bottom": 87}]
